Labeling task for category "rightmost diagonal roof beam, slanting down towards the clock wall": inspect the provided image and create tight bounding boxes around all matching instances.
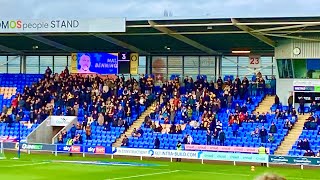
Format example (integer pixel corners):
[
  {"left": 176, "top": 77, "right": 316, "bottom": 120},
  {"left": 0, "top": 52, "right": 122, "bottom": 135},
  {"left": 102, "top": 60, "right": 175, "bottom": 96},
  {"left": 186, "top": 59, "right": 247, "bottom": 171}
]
[{"left": 231, "top": 18, "right": 276, "bottom": 47}]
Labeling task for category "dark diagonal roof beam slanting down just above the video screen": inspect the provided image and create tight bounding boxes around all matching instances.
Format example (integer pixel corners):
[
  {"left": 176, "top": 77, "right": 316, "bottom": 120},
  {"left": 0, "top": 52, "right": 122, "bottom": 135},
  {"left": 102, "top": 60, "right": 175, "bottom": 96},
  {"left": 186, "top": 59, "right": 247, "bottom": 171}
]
[{"left": 92, "top": 34, "right": 150, "bottom": 55}]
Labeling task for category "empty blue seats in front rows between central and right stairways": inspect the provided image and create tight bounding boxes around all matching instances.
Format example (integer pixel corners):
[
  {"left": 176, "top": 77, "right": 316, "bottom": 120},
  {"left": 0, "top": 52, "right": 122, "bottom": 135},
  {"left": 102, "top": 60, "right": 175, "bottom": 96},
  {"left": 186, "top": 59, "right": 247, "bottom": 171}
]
[{"left": 129, "top": 109, "right": 294, "bottom": 154}]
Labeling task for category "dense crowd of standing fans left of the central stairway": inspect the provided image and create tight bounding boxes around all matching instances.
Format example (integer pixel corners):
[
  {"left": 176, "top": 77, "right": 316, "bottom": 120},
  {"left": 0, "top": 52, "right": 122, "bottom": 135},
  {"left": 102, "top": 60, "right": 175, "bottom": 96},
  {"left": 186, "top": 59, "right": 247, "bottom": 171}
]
[{"left": 0, "top": 67, "right": 159, "bottom": 142}]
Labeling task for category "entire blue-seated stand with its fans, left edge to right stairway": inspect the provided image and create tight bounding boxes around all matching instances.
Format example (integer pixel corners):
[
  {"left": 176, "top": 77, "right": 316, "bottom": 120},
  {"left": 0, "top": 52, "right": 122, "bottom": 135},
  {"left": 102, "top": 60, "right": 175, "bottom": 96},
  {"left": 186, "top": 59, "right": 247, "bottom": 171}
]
[{"left": 0, "top": 69, "right": 296, "bottom": 153}]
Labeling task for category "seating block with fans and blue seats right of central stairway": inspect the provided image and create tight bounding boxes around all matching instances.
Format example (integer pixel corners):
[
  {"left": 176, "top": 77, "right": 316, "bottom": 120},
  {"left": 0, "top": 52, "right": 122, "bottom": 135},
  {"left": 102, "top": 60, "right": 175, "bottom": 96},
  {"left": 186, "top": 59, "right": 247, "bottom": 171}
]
[{"left": 126, "top": 75, "right": 284, "bottom": 154}]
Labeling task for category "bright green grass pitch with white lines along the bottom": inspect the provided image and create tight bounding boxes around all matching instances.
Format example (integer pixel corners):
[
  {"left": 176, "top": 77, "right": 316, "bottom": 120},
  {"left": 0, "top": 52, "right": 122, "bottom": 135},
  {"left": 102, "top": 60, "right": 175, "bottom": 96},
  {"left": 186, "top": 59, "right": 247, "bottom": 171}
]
[{"left": 0, "top": 153, "right": 320, "bottom": 180}]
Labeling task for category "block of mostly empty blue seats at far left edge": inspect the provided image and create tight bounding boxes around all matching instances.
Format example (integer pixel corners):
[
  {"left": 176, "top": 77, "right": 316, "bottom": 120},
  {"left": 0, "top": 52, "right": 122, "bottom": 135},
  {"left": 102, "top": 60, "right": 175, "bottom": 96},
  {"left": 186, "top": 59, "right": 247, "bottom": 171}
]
[{"left": 0, "top": 74, "right": 43, "bottom": 141}]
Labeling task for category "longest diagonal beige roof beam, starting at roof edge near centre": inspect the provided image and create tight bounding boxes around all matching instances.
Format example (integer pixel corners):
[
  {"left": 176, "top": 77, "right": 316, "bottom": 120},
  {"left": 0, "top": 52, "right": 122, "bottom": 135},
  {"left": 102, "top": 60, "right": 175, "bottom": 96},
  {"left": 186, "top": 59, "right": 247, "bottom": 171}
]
[{"left": 148, "top": 20, "right": 221, "bottom": 55}]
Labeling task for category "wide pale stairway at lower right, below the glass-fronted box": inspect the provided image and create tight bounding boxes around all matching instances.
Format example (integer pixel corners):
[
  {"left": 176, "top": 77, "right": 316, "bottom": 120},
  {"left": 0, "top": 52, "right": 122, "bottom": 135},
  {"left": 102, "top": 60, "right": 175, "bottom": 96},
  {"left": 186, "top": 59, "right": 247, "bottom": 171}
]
[{"left": 275, "top": 115, "right": 310, "bottom": 155}]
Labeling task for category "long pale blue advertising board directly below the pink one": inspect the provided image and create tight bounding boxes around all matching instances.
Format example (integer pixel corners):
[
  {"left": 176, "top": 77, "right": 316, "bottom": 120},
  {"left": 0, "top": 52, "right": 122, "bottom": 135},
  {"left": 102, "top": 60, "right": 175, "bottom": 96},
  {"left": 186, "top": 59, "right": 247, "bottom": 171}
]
[{"left": 199, "top": 152, "right": 269, "bottom": 163}]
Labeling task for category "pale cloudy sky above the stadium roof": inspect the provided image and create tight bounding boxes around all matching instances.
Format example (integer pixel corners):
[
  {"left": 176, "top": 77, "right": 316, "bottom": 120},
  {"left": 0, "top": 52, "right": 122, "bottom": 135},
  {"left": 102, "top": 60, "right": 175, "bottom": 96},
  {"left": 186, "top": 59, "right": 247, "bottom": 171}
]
[{"left": 0, "top": 0, "right": 320, "bottom": 19}]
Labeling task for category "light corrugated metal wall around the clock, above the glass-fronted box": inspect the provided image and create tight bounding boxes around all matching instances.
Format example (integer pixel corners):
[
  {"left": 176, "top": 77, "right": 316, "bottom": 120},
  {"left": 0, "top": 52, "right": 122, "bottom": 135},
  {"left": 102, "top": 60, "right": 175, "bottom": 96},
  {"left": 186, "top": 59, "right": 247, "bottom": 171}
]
[{"left": 275, "top": 37, "right": 320, "bottom": 59}]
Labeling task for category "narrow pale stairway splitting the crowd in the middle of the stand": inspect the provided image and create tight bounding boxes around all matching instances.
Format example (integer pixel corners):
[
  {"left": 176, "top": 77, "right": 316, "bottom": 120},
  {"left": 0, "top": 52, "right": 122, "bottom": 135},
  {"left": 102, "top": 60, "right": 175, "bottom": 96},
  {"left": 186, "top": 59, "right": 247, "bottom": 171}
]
[{"left": 112, "top": 98, "right": 162, "bottom": 147}]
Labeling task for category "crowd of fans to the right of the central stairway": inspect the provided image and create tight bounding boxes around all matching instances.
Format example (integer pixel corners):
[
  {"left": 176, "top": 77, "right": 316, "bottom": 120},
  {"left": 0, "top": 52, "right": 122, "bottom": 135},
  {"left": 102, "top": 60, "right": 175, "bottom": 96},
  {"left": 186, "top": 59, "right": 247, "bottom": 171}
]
[{"left": 135, "top": 73, "right": 282, "bottom": 145}]
